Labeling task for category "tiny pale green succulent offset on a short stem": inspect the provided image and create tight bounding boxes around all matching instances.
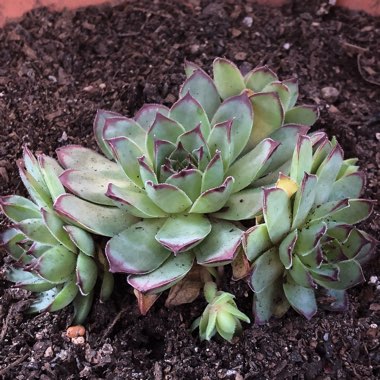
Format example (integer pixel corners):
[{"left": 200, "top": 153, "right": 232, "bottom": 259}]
[{"left": 191, "top": 282, "right": 250, "bottom": 342}]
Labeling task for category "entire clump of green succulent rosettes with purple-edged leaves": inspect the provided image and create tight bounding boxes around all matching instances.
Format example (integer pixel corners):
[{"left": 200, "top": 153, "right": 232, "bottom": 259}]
[{"left": 0, "top": 58, "right": 376, "bottom": 341}]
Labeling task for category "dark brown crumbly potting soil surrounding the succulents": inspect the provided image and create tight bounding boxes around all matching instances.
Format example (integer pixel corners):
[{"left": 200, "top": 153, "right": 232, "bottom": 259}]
[{"left": 0, "top": 0, "right": 380, "bottom": 380}]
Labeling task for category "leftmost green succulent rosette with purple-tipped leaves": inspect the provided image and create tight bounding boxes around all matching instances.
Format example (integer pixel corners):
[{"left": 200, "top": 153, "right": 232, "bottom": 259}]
[{"left": 0, "top": 148, "right": 113, "bottom": 323}]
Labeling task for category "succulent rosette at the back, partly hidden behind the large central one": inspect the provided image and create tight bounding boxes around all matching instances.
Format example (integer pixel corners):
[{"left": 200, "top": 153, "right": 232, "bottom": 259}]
[{"left": 184, "top": 58, "right": 319, "bottom": 151}]
